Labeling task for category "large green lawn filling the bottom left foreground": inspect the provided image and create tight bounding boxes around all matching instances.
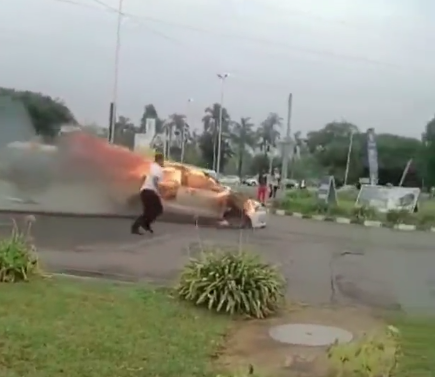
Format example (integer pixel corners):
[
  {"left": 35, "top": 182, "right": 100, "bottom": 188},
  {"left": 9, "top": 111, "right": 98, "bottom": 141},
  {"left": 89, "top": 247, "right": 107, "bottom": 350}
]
[{"left": 0, "top": 278, "right": 232, "bottom": 377}]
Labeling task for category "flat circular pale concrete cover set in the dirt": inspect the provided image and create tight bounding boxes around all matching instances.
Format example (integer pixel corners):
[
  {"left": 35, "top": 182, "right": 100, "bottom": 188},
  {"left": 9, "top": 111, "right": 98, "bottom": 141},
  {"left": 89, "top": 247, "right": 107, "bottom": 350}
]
[{"left": 269, "top": 323, "right": 353, "bottom": 347}]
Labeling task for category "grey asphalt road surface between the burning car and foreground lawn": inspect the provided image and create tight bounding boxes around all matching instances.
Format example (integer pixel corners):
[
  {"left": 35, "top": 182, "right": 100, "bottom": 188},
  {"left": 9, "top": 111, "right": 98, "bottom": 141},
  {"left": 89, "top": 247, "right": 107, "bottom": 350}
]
[{"left": 0, "top": 215, "right": 435, "bottom": 312}]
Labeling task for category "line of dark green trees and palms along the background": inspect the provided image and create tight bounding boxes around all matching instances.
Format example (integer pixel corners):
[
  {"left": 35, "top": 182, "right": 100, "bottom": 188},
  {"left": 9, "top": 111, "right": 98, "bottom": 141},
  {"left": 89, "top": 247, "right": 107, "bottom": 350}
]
[{"left": 0, "top": 88, "right": 435, "bottom": 187}]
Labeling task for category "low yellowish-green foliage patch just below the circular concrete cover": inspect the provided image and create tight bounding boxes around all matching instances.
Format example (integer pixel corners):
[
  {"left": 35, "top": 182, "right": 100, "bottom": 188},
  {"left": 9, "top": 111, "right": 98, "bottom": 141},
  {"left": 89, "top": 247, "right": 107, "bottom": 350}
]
[{"left": 327, "top": 326, "right": 401, "bottom": 377}]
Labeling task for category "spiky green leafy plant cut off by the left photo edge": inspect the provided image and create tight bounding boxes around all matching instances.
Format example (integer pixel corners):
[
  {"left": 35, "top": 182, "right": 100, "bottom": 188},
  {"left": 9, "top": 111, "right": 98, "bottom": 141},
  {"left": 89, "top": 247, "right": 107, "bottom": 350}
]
[{"left": 0, "top": 218, "right": 39, "bottom": 283}]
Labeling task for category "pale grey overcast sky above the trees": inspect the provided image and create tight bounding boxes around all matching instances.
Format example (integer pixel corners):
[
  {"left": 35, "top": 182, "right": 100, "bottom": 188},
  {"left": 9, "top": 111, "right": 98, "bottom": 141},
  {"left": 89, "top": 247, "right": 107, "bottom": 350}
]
[{"left": 0, "top": 0, "right": 435, "bottom": 137}]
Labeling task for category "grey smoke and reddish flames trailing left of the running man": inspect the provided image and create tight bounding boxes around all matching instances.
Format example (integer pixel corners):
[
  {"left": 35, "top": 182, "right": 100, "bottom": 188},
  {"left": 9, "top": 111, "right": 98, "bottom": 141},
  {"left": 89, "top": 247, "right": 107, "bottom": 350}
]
[{"left": 0, "top": 122, "right": 148, "bottom": 214}]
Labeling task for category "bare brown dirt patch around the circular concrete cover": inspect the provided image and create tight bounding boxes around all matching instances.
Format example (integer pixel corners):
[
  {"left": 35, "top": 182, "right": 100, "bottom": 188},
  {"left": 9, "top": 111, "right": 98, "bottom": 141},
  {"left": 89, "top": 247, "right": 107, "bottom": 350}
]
[{"left": 218, "top": 307, "right": 383, "bottom": 377}]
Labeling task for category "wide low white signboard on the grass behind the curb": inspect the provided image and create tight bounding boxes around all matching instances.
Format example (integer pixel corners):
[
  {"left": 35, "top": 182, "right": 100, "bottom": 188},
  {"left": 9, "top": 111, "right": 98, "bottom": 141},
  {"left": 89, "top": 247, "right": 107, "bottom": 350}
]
[{"left": 355, "top": 185, "right": 420, "bottom": 212}]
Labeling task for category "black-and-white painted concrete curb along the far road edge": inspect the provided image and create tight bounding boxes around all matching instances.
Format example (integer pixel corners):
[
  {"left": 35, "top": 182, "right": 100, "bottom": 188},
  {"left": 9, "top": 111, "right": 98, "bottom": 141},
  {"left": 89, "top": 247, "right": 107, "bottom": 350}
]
[{"left": 269, "top": 208, "right": 435, "bottom": 233}]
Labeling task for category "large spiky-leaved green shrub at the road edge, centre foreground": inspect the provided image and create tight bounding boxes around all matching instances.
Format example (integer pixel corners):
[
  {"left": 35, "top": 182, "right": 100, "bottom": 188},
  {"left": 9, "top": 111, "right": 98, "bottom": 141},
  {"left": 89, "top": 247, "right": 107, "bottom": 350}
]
[{"left": 176, "top": 249, "right": 285, "bottom": 318}]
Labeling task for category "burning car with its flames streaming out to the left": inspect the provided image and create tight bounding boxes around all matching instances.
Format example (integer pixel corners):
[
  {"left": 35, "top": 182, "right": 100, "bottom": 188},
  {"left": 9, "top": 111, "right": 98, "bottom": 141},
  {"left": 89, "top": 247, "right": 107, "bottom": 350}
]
[{"left": 59, "top": 132, "right": 267, "bottom": 228}]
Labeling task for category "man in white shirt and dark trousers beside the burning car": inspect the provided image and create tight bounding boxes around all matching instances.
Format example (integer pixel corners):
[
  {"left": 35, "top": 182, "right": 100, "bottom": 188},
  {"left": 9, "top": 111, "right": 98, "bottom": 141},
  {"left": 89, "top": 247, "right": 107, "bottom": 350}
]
[{"left": 131, "top": 153, "right": 164, "bottom": 234}]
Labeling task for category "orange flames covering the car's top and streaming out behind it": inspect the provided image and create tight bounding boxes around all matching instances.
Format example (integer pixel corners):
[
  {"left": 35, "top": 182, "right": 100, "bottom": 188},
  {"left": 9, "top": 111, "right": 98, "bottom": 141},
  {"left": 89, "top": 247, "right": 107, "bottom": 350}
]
[{"left": 60, "top": 131, "right": 259, "bottom": 213}]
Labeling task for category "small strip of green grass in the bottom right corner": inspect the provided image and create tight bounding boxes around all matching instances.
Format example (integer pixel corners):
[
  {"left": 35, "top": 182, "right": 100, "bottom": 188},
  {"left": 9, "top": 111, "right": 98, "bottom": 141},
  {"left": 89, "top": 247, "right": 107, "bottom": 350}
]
[{"left": 393, "top": 316, "right": 435, "bottom": 377}]
